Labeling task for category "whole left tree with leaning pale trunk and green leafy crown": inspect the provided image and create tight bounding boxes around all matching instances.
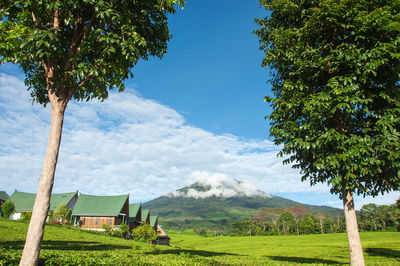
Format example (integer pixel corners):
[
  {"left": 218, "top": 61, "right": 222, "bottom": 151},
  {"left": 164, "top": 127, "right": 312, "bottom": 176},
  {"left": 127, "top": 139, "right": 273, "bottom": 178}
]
[{"left": 0, "top": 0, "right": 184, "bottom": 265}]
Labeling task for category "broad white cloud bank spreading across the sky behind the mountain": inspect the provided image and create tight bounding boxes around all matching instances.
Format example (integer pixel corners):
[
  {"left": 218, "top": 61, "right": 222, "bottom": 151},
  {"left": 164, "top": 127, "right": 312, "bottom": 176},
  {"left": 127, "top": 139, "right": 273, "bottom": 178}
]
[{"left": 0, "top": 73, "right": 399, "bottom": 208}]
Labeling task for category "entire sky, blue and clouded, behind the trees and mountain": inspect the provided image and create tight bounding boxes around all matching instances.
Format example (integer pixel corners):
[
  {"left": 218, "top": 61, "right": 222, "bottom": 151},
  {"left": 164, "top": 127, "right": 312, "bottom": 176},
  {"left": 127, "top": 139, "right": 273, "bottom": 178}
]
[{"left": 0, "top": 0, "right": 399, "bottom": 208}]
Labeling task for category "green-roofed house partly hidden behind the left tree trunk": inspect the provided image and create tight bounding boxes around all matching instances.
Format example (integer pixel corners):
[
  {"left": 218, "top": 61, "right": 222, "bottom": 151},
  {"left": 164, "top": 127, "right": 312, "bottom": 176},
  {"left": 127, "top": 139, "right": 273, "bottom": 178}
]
[{"left": 7, "top": 190, "right": 78, "bottom": 220}]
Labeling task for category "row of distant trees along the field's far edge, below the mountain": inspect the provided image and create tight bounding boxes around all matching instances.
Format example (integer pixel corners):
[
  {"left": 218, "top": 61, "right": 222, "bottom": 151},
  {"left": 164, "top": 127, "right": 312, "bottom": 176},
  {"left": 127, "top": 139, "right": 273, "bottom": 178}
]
[{"left": 231, "top": 199, "right": 400, "bottom": 236}]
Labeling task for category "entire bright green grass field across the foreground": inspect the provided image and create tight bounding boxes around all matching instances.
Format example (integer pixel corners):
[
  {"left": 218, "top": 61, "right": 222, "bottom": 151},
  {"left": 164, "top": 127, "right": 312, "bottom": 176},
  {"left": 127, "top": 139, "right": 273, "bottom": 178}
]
[{"left": 0, "top": 219, "right": 400, "bottom": 265}]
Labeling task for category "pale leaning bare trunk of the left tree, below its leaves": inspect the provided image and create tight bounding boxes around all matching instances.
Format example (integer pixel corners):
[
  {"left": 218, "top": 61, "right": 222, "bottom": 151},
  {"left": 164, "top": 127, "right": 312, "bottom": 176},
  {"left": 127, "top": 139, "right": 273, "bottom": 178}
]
[{"left": 20, "top": 99, "right": 66, "bottom": 266}]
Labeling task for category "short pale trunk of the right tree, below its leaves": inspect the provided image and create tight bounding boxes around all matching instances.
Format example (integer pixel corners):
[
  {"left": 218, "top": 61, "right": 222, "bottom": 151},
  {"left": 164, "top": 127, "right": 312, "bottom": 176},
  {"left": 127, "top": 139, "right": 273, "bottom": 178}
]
[{"left": 343, "top": 191, "right": 365, "bottom": 266}]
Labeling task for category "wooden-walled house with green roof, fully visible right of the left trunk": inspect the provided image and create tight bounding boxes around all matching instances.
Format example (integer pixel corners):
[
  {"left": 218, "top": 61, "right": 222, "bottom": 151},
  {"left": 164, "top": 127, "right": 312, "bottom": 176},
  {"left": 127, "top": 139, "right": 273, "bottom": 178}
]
[{"left": 72, "top": 193, "right": 129, "bottom": 230}]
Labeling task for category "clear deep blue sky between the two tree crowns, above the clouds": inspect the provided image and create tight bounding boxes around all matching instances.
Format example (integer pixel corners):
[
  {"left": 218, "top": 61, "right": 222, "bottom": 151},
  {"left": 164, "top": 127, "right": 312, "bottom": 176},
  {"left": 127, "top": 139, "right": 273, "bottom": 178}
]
[{"left": 131, "top": 0, "right": 268, "bottom": 139}]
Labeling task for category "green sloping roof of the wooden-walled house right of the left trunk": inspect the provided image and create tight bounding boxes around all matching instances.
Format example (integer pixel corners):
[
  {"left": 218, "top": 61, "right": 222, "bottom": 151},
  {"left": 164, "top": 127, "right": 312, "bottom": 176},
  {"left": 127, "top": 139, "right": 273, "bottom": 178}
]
[{"left": 72, "top": 193, "right": 129, "bottom": 217}]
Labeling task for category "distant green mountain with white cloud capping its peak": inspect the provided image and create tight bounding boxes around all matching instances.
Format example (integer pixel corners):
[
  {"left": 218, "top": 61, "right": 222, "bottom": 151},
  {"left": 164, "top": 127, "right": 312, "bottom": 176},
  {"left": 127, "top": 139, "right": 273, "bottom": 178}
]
[{"left": 143, "top": 179, "right": 343, "bottom": 229}]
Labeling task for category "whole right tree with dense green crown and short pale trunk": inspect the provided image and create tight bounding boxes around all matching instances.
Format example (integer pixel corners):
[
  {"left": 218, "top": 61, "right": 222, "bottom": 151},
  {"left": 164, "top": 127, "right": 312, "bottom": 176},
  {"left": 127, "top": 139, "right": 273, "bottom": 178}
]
[{"left": 255, "top": 0, "right": 400, "bottom": 265}]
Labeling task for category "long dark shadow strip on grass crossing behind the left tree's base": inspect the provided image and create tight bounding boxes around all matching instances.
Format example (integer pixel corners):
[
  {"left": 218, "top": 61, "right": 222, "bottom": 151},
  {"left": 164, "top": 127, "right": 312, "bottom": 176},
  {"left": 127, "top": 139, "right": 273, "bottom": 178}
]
[{"left": 0, "top": 240, "right": 132, "bottom": 250}]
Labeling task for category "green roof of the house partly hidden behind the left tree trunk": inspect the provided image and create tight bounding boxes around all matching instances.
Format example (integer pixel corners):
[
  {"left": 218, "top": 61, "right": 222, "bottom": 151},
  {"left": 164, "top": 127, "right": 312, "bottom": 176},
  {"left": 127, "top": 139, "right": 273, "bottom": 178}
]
[{"left": 8, "top": 191, "right": 78, "bottom": 212}]
